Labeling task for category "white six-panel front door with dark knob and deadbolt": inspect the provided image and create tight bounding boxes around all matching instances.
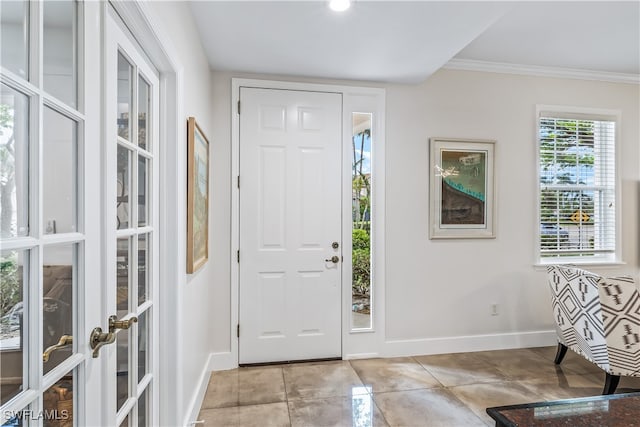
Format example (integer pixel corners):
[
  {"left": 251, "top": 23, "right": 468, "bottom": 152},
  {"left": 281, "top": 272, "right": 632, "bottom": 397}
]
[{"left": 239, "top": 87, "right": 342, "bottom": 364}]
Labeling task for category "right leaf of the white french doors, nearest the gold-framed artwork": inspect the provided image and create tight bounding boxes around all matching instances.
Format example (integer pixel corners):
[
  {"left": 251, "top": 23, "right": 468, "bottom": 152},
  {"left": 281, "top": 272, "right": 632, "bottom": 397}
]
[{"left": 101, "top": 8, "right": 159, "bottom": 426}]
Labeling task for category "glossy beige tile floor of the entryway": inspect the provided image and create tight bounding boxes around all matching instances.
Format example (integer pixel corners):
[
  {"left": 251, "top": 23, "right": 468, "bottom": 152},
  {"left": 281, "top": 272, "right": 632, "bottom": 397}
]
[{"left": 199, "top": 347, "right": 640, "bottom": 427}]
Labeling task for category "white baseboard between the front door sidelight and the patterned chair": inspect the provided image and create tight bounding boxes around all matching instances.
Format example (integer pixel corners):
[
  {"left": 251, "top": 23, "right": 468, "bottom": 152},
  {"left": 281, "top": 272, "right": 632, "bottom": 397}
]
[{"left": 380, "top": 330, "right": 558, "bottom": 357}]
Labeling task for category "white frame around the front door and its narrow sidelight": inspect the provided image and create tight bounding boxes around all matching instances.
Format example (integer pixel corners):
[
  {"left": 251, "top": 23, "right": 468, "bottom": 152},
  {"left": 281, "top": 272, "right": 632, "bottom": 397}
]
[{"left": 232, "top": 78, "right": 386, "bottom": 369}]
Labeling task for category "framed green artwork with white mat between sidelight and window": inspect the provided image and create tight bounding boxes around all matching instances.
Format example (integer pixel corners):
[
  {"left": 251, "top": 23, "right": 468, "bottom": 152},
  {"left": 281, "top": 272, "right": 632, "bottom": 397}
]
[{"left": 429, "top": 138, "right": 496, "bottom": 239}]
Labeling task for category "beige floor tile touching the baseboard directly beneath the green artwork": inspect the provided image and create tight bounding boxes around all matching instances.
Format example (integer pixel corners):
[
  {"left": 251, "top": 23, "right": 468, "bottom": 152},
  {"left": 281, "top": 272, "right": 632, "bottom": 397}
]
[{"left": 414, "top": 353, "right": 508, "bottom": 387}]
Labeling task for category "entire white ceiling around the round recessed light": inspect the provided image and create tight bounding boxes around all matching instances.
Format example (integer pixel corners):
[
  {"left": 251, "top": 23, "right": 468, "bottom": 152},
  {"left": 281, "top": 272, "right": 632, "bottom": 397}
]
[{"left": 191, "top": 0, "right": 640, "bottom": 83}]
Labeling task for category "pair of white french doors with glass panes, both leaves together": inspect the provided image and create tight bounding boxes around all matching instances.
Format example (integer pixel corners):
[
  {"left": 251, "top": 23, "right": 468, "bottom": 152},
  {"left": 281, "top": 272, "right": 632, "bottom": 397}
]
[{"left": 0, "top": 0, "right": 159, "bottom": 427}]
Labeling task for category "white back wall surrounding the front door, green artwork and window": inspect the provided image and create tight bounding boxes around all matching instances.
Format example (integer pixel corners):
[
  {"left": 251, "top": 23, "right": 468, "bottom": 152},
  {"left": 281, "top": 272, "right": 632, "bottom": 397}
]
[{"left": 211, "top": 70, "right": 640, "bottom": 355}]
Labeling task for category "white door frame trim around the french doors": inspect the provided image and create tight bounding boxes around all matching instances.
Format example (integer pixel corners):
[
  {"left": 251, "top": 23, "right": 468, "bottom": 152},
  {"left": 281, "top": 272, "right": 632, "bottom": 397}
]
[{"left": 101, "top": 0, "right": 184, "bottom": 425}]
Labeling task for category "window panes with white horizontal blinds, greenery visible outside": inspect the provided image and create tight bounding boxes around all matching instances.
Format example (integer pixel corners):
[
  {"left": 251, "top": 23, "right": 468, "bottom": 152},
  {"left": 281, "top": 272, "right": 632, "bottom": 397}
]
[{"left": 538, "top": 117, "right": 613, "bottom": 256}]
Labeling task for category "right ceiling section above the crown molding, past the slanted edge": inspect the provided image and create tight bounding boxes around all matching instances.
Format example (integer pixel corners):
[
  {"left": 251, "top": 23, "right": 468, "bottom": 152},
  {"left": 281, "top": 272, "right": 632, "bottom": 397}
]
[{"left": 456, "top": 1, "right": 640, "bottom": 74}]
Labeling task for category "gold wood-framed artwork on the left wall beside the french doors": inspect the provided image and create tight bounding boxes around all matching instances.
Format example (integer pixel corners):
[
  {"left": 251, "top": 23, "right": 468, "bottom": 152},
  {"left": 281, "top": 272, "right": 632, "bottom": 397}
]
[{"left": 187, "top": 117, "right": 209, "bottom": 273}]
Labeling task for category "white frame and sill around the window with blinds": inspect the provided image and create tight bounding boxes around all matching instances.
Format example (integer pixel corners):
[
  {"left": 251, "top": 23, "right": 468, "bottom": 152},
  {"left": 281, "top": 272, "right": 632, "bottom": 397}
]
[{"left": 534, "top": 105, "right": 624, "bottom": 266}]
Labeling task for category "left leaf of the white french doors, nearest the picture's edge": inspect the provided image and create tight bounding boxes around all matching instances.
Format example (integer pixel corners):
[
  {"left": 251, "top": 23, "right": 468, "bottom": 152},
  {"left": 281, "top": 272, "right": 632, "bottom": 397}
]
[{"left": 0, "top": 1, "right": 89, "bottom": 426}]
